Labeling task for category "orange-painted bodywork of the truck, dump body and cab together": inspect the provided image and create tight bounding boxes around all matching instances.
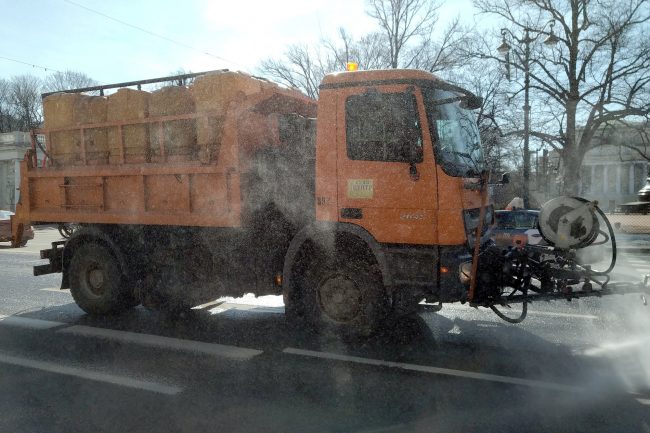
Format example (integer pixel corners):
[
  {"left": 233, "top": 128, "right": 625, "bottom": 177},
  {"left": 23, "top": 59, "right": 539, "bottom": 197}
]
[{"left": 12, "top": 70, "right": 481, "bottom": 253}]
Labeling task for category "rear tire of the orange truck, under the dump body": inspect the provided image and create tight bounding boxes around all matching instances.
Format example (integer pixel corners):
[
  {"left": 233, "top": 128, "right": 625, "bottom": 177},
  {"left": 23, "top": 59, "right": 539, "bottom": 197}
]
[{"left": 68, "top": 243, "right": 135, "bottom": 315}]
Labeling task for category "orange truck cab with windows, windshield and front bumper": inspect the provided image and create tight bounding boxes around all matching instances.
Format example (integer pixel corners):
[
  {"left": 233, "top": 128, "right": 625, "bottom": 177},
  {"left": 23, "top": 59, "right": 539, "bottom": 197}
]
[{"left": 284, "top": 70, "right": 493, "bottom": 332}]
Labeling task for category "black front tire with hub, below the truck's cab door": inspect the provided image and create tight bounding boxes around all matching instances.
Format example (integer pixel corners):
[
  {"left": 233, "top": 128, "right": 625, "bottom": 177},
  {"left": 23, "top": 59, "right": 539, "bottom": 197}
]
[{"left": 303, "top": 259, "right": 389, "bottom": 338}]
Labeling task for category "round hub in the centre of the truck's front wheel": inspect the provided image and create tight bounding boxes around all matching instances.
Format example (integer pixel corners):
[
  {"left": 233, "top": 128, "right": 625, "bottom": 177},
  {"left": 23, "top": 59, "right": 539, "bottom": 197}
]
[{"left": 318, "top": 274, "right": 361, "bottom": 322}]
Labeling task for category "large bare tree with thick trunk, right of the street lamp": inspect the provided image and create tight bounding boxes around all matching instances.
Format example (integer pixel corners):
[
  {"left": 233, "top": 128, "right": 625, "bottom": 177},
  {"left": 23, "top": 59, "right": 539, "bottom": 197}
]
[{"left": 474, "top": 0, "right": 650, "bottom": 194}]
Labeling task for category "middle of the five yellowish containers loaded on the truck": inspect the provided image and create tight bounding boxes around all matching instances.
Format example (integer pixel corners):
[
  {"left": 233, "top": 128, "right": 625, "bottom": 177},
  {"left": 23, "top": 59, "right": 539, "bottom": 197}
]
[{"left": 106, "top": 88, "right": 150, "bottom": 164}]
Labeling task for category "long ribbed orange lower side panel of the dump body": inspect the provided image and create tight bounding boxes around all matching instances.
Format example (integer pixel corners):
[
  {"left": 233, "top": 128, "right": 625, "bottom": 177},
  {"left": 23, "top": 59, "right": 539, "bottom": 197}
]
[{"left": 22, "top": 165, "right": 240, "bottom": 227}]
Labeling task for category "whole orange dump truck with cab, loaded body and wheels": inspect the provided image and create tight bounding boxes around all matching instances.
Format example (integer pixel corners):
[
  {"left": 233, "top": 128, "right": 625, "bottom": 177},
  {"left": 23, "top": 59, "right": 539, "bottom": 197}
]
[{"left": 12, "top": 70, "right": 493, "bottom": 334}]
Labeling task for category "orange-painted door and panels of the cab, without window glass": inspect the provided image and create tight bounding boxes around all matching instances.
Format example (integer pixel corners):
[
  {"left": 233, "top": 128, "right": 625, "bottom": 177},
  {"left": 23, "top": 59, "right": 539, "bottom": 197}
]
[{"left": 316, "top": 70, "right": 481, "bottom": 245}]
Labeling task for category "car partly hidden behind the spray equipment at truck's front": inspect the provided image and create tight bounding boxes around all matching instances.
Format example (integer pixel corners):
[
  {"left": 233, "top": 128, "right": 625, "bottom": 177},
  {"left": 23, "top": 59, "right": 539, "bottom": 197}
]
[{"left": 492, "top": 209, "right": 546, "bottom": 247}]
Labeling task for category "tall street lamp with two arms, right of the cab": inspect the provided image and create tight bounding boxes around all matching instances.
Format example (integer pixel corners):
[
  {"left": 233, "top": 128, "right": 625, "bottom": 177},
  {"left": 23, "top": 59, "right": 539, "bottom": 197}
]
[{"left": 497, "top": 20, "right": 559, "bottom": 209}]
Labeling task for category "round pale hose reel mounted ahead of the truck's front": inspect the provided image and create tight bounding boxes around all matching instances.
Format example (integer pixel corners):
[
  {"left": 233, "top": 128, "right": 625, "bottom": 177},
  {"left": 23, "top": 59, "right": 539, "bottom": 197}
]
[{"left": 539, "top": 197, "right": 600, "bottom": 249}]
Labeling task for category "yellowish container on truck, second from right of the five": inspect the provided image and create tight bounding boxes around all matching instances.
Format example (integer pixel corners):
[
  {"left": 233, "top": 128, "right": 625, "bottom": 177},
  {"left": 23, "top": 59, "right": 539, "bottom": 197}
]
[{"left": 149, "top": 86, "right": 196, "bottom": 160}]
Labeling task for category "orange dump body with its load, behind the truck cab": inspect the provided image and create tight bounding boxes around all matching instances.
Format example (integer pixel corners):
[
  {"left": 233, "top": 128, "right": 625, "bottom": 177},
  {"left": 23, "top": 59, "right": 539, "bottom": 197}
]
[{"left": 16, "top": 73, "right": 316, "bottom": 231}]
